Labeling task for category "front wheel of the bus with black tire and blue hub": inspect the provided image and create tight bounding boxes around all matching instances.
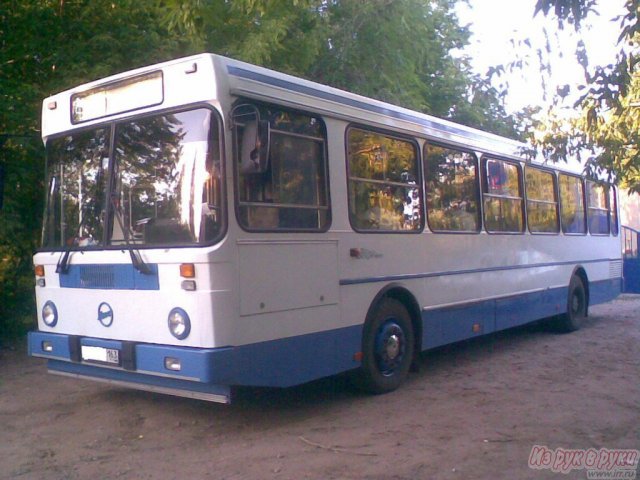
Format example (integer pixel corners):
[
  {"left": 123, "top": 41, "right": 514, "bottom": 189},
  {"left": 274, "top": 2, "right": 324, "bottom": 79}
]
[{"left": 358, "top": 298, "right": 415, "bottom": 393}]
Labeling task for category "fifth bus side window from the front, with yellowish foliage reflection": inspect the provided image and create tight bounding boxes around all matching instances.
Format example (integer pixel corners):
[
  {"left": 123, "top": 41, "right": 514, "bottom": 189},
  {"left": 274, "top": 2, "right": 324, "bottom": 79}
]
[{"left": 525, "top": 167, "right": 560, "bottom": 233}]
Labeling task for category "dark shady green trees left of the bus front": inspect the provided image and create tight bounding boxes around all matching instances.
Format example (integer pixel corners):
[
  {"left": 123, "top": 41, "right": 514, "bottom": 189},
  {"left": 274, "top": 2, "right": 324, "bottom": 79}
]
[{"left": 0, "top": 0, "right": 184, "bottom": 337}]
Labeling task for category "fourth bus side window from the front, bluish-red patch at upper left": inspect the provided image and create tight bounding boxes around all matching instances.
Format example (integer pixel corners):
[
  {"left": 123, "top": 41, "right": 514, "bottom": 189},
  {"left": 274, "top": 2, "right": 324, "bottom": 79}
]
[{"left": 483, "top": 160, "right": 524, "bottom": 233}]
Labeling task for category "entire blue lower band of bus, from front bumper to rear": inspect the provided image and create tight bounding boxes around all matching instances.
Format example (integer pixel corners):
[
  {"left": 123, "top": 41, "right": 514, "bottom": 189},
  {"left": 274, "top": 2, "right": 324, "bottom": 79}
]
[{"left": 28, "top": 278, "right": 622, "bottom": 392}]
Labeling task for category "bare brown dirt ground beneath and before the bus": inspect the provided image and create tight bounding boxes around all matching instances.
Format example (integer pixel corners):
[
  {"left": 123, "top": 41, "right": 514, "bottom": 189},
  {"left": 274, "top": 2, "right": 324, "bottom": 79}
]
[{"left": 0, "top": 295, "right": 640, "bottom": 480}]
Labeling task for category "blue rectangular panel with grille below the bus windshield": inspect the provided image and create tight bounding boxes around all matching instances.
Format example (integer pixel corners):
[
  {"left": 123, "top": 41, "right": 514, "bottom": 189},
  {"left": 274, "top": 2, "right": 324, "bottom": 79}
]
[{"left": 59, "top": 263, "right": 160, "bottom": 290}]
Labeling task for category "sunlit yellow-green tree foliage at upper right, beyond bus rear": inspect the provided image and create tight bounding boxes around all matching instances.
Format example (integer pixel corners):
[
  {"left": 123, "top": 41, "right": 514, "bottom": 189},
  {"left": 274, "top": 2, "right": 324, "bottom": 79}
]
[{"left": 531, "top": 0, "right": 640, "bottom": 192}]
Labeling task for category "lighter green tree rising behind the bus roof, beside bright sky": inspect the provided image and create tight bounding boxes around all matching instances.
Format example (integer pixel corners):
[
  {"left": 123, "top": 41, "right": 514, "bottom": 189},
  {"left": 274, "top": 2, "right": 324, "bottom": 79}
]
[{"left": 163, "top": 0, "right": 519, "bottom": 138}]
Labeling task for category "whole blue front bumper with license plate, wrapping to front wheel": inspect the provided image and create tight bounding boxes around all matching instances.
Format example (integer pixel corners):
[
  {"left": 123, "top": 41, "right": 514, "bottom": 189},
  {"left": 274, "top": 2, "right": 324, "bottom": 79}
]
[{"left": 29, "top": 325, "right": 362, "bottom": 403}]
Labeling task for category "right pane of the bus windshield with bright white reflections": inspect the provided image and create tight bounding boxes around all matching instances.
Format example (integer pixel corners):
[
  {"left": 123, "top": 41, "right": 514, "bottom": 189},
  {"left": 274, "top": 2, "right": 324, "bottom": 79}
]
[{"left": 111, "top": 109, "right": 221, "bottom": 245}]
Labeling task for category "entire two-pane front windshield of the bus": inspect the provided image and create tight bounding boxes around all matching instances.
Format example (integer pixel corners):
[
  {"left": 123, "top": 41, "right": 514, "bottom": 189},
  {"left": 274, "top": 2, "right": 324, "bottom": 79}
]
[{"left": 43, "top": 108, "right": 222, "bottom": 248}]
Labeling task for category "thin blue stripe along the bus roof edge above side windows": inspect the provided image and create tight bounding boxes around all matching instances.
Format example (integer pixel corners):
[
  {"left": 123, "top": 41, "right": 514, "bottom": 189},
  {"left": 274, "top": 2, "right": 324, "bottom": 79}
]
[{"left": 227, "top": 66, "right": 500, "bottom": 146}]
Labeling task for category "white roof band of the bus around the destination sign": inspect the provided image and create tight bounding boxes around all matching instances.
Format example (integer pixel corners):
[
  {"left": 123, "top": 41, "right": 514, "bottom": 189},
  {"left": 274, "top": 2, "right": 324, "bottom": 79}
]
[{"left": 42, "top": 54, "right": 574, "bottom": 174}]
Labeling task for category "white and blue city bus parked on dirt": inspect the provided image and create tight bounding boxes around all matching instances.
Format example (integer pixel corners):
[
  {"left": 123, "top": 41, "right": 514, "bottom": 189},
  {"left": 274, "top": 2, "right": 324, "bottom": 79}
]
[{"left": 28, "top": 54, "right": 622, "bottom": 402}]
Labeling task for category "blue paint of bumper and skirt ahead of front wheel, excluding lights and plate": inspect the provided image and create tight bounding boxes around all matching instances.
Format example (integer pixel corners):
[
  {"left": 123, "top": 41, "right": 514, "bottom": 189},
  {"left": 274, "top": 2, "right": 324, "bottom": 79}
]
[{"left": 28, "top": 325, "right": 362, "bottom": 391}]
